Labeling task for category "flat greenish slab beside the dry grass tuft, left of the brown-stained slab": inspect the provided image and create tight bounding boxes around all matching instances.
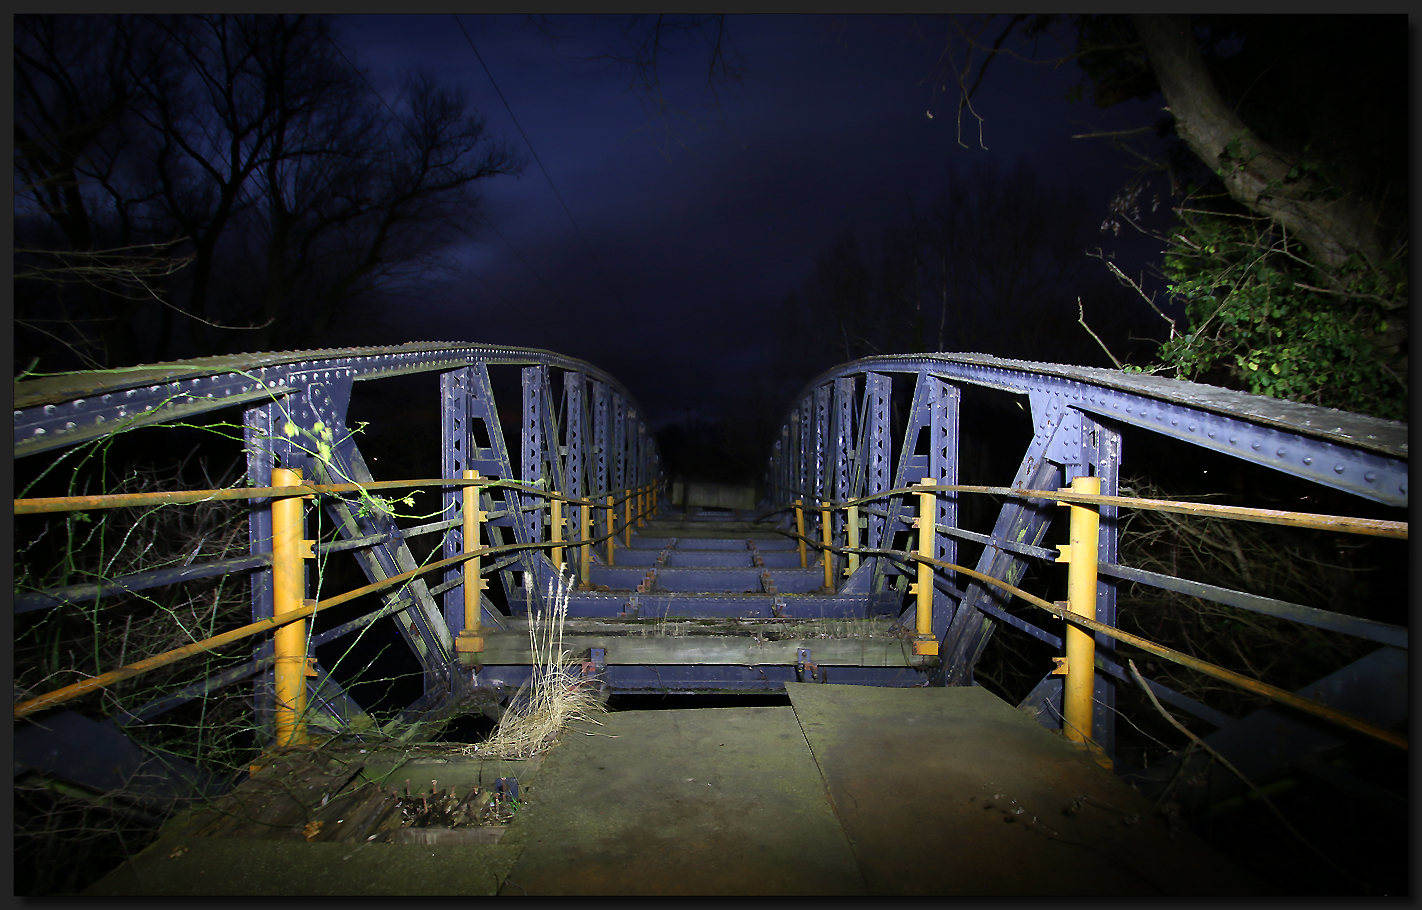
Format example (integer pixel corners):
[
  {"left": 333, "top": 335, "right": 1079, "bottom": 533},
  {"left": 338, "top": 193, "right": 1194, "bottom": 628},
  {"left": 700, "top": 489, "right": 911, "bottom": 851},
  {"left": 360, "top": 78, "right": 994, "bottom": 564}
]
[{"left": 501, "top": 707, "right": 865, "bottom": 896}]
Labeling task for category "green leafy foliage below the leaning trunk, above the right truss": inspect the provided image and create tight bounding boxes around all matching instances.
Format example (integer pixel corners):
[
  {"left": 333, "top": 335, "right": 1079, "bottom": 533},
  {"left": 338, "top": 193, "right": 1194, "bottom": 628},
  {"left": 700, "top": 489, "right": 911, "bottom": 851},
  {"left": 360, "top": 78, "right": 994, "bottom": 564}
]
[{"left": 1159, "top": 199, "right": 1408, "bottom": 419}]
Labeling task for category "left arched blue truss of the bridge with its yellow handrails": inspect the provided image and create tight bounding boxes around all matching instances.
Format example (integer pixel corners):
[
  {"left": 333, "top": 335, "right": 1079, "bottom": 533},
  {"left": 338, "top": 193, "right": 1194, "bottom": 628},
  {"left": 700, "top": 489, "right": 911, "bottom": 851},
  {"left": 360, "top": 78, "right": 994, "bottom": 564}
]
[{"left": 14, "top": 343, "right": 661, "bottom": 741}]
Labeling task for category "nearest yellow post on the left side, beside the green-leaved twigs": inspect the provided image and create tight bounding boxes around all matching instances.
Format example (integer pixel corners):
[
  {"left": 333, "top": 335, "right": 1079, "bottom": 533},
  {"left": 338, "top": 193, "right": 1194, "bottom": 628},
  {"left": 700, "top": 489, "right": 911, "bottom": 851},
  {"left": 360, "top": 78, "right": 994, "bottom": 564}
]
[{"left": 272, "top": 468, "right": 310, "bottom": 746}]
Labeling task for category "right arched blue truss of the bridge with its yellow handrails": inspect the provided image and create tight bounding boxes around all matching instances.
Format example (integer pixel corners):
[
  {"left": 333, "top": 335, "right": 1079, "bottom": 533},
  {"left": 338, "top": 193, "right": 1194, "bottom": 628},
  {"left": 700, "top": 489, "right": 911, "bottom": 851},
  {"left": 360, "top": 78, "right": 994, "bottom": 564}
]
[{"left": 764, "top": 354, "right": 1408, "bottom": 751}]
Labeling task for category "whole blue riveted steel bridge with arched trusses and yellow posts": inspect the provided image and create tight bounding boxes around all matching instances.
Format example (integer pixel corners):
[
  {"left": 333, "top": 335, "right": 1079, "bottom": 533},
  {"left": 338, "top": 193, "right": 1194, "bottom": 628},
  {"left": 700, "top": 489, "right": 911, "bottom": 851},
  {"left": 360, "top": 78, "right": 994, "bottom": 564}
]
[{"left": 14, "top": 344, "right": 1408, "bottom": 898}]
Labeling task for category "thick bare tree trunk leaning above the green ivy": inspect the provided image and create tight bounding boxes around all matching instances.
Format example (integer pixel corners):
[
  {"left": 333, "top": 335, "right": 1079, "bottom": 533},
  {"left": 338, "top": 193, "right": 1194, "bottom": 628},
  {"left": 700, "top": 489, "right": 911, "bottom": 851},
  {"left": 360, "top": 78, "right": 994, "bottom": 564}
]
[{"left": 1130, "top": 14, "right": 1384, "bottom": 269}]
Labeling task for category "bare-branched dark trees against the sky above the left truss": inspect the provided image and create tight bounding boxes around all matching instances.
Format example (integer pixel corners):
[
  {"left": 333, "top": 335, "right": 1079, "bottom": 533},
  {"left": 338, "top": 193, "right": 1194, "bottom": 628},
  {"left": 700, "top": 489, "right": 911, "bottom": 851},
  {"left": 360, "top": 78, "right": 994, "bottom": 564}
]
[{"left": 14, "top": 16, "right": 520, "bottom": 374}]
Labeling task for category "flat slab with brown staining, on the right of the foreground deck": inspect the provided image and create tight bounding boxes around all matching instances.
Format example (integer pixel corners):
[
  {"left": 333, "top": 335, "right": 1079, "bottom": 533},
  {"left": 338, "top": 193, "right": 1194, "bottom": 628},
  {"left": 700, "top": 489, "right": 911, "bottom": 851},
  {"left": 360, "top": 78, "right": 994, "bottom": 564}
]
[{"left": 785, "top": 683, "right": 1267, "bottom": 896}]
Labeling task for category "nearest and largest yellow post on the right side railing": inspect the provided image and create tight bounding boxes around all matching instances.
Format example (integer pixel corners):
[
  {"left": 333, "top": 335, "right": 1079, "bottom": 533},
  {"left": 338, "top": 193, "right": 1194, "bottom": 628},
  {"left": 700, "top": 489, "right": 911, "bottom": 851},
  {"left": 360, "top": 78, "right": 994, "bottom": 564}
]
[{"left": 1057, "top": 478, "right": 1103, "bottom": 761}]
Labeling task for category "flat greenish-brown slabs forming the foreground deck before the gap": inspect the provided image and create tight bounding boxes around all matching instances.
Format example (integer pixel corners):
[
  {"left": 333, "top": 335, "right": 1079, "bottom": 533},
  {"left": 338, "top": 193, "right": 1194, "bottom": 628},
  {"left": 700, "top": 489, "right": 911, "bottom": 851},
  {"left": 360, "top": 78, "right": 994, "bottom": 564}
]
[{"left": 88, "top": 684, "right": 1264, "bottom": 896}]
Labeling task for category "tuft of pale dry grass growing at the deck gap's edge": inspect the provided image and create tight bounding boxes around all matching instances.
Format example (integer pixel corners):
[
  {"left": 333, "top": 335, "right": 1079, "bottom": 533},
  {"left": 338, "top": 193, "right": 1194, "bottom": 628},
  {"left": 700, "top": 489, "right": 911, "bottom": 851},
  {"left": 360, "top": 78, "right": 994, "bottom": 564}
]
[{"left": 459, "top": 570, "right": 604, "bottom": 759}]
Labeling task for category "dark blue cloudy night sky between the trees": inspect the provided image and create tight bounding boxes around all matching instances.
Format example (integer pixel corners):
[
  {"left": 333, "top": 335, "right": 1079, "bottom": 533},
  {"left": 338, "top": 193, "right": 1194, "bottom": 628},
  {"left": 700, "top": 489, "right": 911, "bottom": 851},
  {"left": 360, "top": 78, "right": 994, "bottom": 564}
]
[{"left": 340, "top": 14, "right": 1159, "bottom": 422}]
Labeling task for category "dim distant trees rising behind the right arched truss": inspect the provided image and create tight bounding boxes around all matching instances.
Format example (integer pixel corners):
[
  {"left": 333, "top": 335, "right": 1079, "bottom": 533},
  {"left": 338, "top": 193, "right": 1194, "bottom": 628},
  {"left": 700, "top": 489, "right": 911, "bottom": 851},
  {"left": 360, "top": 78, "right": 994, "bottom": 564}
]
[{"left": 775, "top": 159, "right": 1160, "bottom": 401}]
